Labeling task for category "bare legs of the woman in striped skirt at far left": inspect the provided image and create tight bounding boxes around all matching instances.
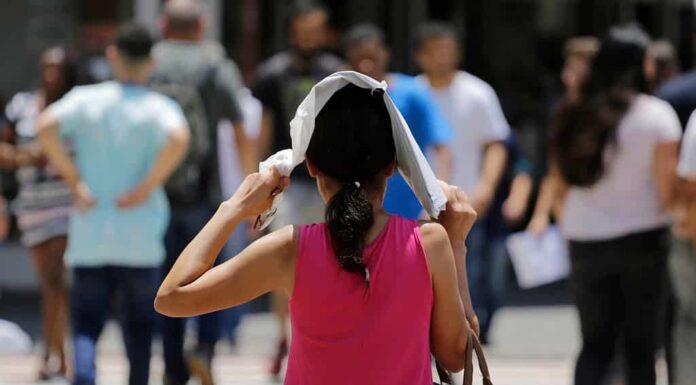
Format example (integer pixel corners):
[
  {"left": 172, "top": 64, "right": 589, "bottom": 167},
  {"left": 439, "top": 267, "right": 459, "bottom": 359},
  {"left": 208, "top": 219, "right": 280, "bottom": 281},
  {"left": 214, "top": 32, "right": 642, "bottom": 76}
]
[{"left": 31, "top": 237, "right": 67, "bottom": 377}]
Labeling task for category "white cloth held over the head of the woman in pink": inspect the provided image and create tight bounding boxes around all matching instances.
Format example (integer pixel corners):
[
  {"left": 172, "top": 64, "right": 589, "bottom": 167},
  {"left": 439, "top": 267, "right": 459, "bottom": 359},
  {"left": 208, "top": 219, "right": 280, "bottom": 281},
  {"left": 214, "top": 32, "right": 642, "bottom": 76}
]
[{"left": 256, "top": 71, "right": 447, "bottom": 228}]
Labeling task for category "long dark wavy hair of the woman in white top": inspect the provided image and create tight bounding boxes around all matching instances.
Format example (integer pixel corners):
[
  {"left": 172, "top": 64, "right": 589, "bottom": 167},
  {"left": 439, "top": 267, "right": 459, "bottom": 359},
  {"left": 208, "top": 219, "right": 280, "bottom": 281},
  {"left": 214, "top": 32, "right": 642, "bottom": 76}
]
[{"left": 551, "top": 24, "right": 649, "bottom": 187}]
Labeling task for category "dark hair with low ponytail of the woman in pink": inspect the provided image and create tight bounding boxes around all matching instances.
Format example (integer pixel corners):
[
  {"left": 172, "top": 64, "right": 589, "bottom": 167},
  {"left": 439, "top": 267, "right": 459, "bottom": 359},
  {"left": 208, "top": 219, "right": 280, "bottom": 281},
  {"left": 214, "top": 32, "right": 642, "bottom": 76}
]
[{"left": 306, "top": 84, "right": 396, "bottom": 283}]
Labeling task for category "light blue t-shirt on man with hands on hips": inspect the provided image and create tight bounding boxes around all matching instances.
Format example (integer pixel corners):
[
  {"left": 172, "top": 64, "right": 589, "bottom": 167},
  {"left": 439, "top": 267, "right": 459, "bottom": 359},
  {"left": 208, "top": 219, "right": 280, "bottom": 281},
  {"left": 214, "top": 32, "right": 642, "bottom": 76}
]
[{"left": 50, "top": 82, "right": 186, "bottom": 267}]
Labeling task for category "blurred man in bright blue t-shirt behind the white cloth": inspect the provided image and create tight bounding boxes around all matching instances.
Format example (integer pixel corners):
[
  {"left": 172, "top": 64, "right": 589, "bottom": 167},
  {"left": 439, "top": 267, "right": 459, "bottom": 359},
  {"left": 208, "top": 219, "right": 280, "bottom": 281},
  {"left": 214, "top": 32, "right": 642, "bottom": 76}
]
[{"left": 345, "top": 24, "right": 452, "bottom": 219}]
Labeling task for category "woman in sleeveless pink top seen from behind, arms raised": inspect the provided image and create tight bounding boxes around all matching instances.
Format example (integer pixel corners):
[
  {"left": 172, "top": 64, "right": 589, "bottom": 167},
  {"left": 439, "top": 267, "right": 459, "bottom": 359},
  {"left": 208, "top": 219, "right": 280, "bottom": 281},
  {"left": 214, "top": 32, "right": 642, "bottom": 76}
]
[{"left": 155, "top": 84, "right": 476, "bottom": 385}]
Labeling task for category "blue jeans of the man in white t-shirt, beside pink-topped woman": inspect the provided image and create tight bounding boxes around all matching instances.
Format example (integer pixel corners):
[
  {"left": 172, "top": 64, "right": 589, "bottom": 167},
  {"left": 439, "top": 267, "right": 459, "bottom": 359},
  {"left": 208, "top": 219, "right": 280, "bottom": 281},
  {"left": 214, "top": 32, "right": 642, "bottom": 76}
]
[{"left": 466, "top": 219, "right": 509, "bottom": 341}]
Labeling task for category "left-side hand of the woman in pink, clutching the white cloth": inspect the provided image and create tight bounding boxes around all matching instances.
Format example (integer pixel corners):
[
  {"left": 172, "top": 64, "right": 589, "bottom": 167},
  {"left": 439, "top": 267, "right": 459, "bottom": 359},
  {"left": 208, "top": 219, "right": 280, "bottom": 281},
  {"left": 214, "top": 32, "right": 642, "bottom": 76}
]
[{"left": 227, "top": 167, "right": 290, "bottom": 218}]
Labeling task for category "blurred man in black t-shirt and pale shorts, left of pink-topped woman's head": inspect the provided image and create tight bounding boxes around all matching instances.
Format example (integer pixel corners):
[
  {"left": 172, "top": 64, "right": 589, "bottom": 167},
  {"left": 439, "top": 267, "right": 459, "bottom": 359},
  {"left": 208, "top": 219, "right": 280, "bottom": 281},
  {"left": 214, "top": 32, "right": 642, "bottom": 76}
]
[{"left": 252, "top": 1, "right": 343, "bottom": 376}]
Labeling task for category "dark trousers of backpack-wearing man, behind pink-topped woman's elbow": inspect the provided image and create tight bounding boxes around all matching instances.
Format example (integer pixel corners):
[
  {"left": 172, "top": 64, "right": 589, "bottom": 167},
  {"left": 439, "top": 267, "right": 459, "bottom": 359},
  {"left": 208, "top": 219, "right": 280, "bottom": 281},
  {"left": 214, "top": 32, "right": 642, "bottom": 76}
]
[{"left": 161, "top": 204, "right": 221, "bottom": 384}]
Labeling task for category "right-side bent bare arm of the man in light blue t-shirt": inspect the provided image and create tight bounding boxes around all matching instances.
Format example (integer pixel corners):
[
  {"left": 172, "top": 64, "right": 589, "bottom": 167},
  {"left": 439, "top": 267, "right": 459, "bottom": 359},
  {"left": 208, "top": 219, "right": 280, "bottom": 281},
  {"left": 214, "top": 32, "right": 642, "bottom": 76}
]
[{"left": 116, "top": 126, "right": 190, "bottom": 208}]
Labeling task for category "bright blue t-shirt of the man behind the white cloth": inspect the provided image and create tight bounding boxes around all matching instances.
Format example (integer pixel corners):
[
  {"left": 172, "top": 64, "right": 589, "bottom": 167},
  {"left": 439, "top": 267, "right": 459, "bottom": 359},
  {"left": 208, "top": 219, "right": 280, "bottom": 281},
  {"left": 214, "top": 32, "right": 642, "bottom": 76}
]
[{"left": 384, "top": 73, "right": 452, "bottom": 219}]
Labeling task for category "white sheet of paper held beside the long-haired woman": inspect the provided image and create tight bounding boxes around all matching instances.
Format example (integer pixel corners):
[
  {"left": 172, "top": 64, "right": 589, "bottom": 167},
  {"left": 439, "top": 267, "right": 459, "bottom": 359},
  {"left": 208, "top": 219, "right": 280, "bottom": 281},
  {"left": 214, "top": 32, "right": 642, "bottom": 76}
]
[{"left": 506, "top": 226, "right": 570, "bottom": 289}]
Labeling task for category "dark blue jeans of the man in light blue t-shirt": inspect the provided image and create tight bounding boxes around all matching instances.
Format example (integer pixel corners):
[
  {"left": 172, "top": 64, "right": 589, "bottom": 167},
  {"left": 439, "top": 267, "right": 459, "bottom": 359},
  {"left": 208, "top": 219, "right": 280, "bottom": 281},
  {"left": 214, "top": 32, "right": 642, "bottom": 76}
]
[{"left": 70, "top": 266, "right": 159, "bottom": 385}]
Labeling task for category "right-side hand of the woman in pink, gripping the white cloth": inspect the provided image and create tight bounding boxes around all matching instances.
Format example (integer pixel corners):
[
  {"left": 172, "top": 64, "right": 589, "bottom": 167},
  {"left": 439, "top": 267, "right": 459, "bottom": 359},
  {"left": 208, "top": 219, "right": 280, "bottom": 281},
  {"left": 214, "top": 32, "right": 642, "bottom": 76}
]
[{"left": 437, "top": 181, "right": 476, "bottom": 244}]
